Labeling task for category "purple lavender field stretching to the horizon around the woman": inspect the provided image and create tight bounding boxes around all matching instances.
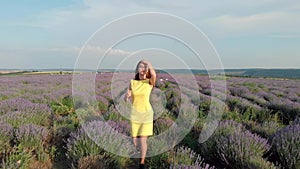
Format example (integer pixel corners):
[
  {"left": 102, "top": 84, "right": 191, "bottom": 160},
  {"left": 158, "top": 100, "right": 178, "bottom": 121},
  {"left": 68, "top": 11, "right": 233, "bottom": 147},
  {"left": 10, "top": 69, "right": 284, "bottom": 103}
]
[{"left": 0, "top": 73, "right": 300, "bottom": 169}]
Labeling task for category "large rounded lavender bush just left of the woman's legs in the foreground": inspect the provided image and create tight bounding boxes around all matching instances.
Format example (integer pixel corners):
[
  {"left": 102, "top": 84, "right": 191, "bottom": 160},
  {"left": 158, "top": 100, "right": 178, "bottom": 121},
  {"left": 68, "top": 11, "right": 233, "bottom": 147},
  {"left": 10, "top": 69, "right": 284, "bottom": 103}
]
[{"left": 66, "top": 121, "right": 133, "bottom": 165}]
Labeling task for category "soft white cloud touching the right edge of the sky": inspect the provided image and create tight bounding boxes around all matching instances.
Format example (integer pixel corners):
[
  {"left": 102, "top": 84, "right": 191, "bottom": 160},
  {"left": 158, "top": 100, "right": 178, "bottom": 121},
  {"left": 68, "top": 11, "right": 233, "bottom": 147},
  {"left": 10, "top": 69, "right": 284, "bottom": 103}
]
[{"left": 206, "top": 11, "right": 300, "bottom": 36}]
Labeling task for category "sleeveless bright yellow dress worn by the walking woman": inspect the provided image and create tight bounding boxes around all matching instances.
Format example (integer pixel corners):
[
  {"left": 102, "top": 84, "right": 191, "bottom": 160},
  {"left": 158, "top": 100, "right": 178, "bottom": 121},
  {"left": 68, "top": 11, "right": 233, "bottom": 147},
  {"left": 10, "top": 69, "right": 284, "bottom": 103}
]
[{"left": 130, "top": 79, "right": 153, "bottom": 137}]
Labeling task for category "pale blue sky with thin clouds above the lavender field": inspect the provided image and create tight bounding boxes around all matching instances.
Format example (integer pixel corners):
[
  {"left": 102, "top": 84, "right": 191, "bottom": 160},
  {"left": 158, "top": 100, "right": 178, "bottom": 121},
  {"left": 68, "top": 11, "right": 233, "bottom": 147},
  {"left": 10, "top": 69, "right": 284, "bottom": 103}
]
[{"left": 0, "top": 0, "right": 300, "bottom": 69}]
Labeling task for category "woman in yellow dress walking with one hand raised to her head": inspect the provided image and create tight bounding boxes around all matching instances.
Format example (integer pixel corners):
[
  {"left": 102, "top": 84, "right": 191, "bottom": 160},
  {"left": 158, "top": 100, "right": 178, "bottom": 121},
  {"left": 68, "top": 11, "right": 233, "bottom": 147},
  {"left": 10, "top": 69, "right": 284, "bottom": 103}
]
[{"left": 125, "top": 60, "right": 156, "bottom": 168}]
